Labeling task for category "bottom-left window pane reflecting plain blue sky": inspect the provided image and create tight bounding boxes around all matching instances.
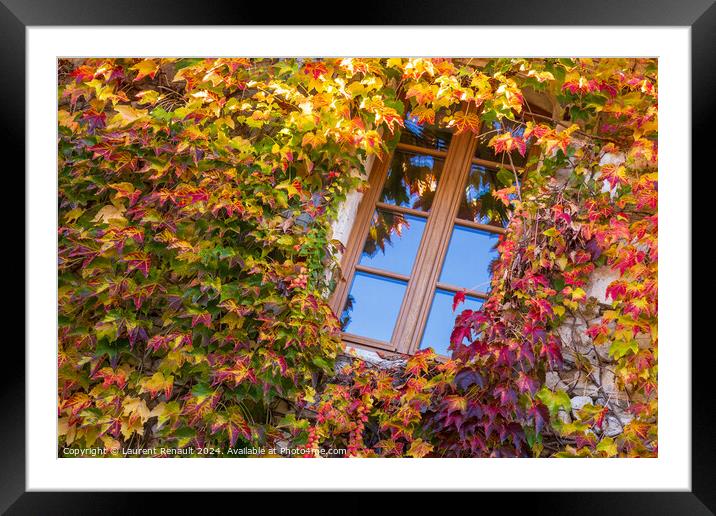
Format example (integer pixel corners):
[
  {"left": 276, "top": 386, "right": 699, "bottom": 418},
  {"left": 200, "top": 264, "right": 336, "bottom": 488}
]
[{"left": 341, "top": 271, "right": 407, "bottom": 342}]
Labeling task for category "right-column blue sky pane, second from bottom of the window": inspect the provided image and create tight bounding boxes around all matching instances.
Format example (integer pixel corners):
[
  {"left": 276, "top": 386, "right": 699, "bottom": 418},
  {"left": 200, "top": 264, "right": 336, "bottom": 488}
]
[{"left": 440, "top": 226, "right": 498, "bottom": 292}]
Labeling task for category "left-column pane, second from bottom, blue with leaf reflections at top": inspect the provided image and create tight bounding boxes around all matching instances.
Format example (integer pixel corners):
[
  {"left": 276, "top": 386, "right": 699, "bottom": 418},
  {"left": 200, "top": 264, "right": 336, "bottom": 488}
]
[{"left": 358, "top": 210, "right": 426, "bottom": 276}]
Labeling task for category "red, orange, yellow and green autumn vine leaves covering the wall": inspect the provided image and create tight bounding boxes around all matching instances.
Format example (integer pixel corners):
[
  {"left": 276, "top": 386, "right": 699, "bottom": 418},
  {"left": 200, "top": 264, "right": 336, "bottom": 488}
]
[{"left": 58, "top": 58, "right": 658, "bottom": 457}]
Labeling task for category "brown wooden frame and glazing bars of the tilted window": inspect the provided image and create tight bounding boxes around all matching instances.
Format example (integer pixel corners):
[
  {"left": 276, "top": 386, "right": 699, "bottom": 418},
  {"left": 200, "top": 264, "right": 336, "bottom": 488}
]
[{"left": 329, "top": 117, "right": 544, "bottom": 355}]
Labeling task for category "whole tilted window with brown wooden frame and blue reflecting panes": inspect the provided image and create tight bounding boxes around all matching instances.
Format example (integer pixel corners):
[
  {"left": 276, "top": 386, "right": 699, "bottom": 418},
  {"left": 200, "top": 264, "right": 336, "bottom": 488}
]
[{"left": 331, "top": 111, "right": 536, "bottom": 355}]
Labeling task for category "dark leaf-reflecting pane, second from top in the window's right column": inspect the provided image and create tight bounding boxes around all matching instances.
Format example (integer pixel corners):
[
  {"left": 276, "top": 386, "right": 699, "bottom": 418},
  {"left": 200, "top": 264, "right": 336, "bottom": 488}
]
[{"left": 457, "top": 165, "right": 508, "bottom": 227}]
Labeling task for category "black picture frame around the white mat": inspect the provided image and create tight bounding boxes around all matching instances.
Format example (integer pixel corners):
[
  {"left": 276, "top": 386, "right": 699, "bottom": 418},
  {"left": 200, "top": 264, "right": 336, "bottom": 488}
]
[{"left": 0, "top": 0, "right": 716, "bottom": 516}]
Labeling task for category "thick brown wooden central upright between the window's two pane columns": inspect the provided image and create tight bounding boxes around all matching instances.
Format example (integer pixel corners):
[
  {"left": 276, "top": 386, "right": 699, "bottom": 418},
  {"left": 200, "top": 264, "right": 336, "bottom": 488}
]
[{"left": 391, "top": 132, "right": 477, "bottom": 353}]
